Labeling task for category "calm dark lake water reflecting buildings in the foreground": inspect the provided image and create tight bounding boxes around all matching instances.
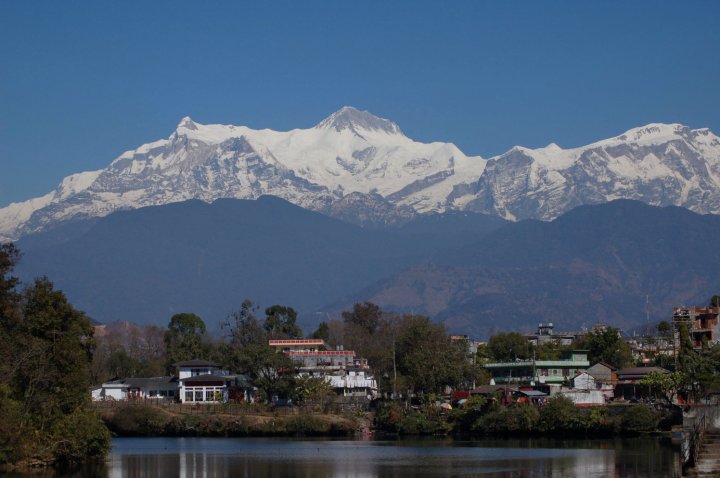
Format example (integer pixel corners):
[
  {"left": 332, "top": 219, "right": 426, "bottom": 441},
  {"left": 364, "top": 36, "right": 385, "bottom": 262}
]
[{"left": 0, "top": 437, "right": 679, "bottom": 478}]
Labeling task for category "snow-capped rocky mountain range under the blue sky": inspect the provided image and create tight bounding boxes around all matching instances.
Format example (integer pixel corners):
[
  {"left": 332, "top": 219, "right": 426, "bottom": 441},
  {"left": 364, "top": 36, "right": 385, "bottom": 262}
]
[{"left": 0, "top": 107, "right": 720, "bottom": 241}]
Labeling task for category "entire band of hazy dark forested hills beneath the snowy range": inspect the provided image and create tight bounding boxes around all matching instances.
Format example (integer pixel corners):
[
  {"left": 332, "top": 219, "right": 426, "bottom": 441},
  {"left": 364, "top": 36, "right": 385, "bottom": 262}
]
[{"left": 11, "top": 197, "right": 720, "bottom": 336}]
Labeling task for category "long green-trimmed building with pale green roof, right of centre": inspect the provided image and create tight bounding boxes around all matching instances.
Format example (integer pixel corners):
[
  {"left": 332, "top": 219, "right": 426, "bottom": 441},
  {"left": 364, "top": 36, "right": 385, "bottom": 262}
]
[{"left": 485, "top": 350, "right": 590, "bottom": 385}]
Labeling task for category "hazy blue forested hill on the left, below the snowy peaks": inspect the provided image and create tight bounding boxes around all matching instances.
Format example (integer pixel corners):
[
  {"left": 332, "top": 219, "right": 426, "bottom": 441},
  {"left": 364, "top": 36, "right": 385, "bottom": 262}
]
[{"left": 18, "top": 196, "right": 505, "bottom": 325}]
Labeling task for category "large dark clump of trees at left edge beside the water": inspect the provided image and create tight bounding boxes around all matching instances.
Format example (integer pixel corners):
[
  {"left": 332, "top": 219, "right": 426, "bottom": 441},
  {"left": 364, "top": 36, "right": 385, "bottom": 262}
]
[{"left": 0, "top": 244, "right": 110, "bottom": 466}]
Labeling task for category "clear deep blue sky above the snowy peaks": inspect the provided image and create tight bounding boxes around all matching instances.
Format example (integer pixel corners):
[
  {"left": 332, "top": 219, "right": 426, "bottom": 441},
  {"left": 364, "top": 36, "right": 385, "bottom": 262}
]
[{"left": 0, "top": 0, "right": 720, "bottom": 206}]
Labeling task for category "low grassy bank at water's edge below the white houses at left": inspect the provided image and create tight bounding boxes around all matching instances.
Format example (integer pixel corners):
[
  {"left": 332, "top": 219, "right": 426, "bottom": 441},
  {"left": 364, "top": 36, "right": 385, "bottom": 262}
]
[{"left": 100, "top": 404, "right": 357, "bottom": 437}]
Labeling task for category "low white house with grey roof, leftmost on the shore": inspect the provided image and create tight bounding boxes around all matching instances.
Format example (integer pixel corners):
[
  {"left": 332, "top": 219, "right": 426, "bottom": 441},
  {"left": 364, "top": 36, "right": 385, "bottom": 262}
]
[{"left": 92, "top": 377, "right": 178, "bottom": 401}]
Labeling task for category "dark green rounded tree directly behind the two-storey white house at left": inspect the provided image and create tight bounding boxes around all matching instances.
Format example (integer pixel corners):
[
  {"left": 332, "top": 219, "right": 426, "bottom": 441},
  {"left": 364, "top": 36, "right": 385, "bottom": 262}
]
[{"left": 165, "top": 313, "right": 208, "bottom": 373}]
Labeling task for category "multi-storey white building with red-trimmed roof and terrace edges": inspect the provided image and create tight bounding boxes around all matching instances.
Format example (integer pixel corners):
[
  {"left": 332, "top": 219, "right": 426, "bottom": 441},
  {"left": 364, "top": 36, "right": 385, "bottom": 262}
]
[{"left": 268, "top": 339, "right": 377, "bottom": 397}]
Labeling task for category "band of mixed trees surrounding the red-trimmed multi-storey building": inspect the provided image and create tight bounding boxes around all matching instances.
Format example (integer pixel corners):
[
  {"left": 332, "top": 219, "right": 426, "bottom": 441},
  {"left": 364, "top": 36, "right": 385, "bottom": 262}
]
[{"left": 92, "top": 300, "right": 480, "bottom": 403}]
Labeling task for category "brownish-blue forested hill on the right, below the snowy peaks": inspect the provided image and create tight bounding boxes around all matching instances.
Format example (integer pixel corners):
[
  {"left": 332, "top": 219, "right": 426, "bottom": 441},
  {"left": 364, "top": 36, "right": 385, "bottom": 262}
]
[{"left": 357, "top": 200, "right": 720, "bottom": 336}]
